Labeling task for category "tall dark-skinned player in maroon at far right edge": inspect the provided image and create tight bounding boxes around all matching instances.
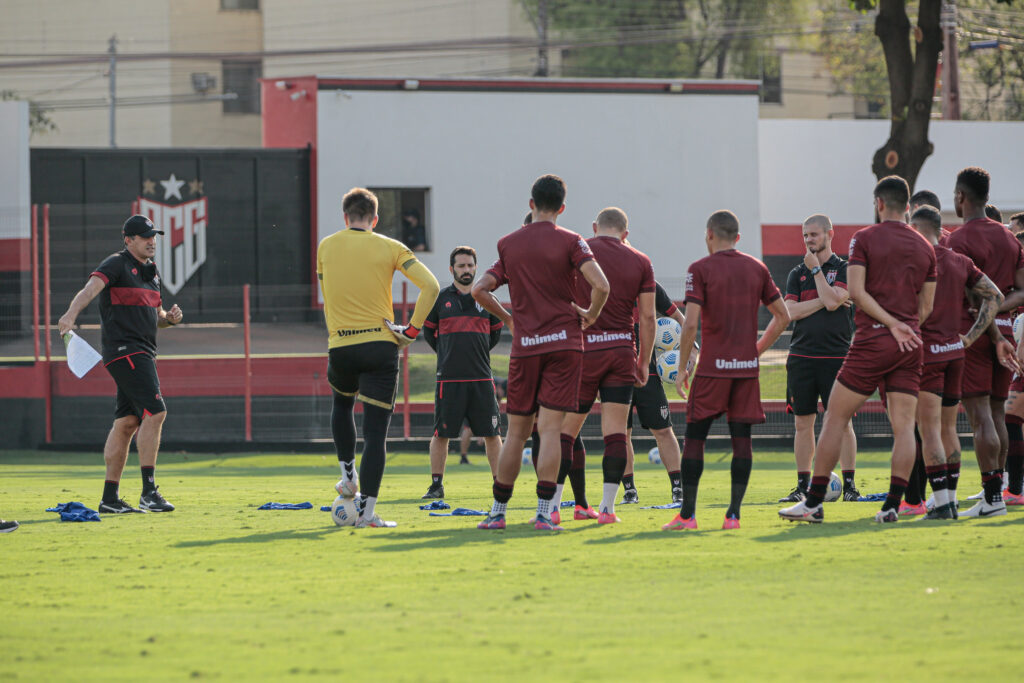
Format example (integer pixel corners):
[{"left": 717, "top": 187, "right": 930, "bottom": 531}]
[{"left": 947, "top": 167, "right": 1024, "bottom": 517}]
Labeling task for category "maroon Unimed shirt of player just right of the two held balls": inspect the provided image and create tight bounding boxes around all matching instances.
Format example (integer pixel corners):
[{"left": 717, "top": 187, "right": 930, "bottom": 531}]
[{"left": 686, "top": 249, "right": 781, "bottom": 377}]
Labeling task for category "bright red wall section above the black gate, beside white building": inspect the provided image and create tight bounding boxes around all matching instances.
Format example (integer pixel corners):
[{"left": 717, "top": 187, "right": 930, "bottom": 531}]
[{"left": 260, "top": 76, "right": 317, "bottom": 147}]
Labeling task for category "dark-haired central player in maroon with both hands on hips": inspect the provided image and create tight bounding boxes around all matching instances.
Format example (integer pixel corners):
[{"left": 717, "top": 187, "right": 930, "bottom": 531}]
[{"left": 473, "top": 175, "right": 608, "bottom": 530}]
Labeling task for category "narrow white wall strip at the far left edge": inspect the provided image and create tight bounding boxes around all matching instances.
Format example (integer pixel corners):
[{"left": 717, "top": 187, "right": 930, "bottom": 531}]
[{"left": 0, "top": 101, "right": 32, "bottom": 240}]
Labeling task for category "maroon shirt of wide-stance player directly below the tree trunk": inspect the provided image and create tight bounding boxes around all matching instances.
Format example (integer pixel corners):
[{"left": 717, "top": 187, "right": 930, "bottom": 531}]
[{"left": 850, "top": 220, "right": 938, "bottom": 343}]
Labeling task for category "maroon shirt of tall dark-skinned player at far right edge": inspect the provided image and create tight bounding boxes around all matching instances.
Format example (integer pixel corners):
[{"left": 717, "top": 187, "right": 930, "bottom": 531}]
[{"left": 936, "top": 217, "right": 1024, "bottom": 341}]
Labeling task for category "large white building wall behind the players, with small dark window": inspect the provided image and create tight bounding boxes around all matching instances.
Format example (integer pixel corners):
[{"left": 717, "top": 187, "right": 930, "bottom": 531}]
[{"left": 317, "top": 90, "right": 761, "bottom": 297}]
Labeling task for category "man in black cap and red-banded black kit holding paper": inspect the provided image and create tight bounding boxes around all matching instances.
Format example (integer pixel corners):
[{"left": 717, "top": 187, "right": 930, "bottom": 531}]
[{"left": 57, "top": 215, "right": 182, "bottom": 514}]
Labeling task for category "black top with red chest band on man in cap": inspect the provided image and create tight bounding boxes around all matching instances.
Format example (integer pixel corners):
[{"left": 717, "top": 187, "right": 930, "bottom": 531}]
[{"left": 90, "top": 249, "right": 161, "bottom": 364}]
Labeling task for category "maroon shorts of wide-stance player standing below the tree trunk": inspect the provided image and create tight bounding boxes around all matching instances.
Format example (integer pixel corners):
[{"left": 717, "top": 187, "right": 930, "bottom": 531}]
[{"left": 836, "top": 332, "right": 925, "bottom": 396}]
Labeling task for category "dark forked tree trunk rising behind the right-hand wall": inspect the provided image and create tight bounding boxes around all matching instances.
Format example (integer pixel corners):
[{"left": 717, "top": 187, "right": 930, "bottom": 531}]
[{"left": 871, "top": 0, "right": 942, "bottom": 191}]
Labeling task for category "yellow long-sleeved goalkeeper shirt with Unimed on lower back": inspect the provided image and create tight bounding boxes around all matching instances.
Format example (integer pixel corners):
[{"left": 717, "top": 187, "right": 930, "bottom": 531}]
[{"left": 316, "top": 228, "right": 440, "bottom": 348}]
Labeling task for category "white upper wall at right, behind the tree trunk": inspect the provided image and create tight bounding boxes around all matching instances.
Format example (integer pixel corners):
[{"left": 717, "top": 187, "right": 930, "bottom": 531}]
[{"left": 758, "top": 120, "right": 1024, "bottom": 224}]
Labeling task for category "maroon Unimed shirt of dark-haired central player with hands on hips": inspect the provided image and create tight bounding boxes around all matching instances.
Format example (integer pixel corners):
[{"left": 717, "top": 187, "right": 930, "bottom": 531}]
[{"left": 487, "top": 221, "right": 594, "bottom": 356}]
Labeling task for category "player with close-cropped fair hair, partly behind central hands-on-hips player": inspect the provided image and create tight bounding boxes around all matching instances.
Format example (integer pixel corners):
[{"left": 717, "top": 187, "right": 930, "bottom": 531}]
[{"left": 561, "top": 207, "right": 654, "bottom": 524}]
